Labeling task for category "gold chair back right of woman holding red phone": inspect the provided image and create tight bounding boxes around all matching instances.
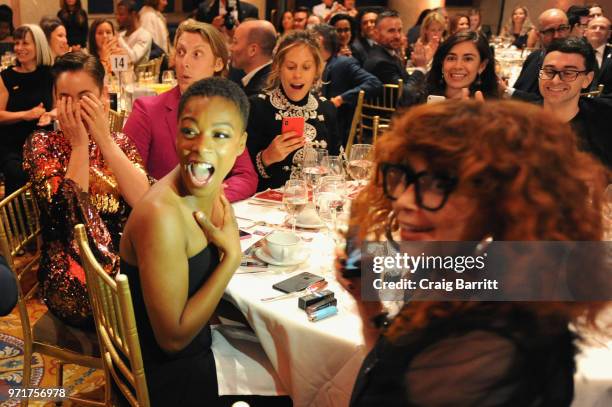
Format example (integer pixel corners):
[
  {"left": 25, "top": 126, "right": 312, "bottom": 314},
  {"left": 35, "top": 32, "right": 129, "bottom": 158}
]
[{"left": 357, "top": 79, "right": 404, "bottom": 143}]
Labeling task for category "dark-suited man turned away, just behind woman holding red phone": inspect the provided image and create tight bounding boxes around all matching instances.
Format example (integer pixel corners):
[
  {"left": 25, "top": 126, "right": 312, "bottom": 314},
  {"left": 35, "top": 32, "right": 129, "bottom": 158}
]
[{"left": 312, "top": 24, "right": 382, "bottom": 145}]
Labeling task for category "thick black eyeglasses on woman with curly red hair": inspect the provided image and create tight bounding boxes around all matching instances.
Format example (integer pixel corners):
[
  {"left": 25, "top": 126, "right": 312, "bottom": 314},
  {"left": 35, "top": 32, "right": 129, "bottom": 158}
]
[{"left": 380, "top": 163, "right": 457, "bottom": 211}]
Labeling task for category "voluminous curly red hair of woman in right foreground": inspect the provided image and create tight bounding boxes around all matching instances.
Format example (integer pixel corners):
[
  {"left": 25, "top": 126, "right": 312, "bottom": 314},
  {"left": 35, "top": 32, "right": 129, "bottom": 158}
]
[{"left": 350, "top": 101, "right": 609, "bottom": 338}]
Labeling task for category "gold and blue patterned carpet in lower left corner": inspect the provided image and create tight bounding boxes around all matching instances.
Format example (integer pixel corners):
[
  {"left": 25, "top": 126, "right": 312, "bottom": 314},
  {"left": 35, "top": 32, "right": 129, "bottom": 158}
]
[{"left": 0, "top": 266, "right": 104, "bottom": 407}]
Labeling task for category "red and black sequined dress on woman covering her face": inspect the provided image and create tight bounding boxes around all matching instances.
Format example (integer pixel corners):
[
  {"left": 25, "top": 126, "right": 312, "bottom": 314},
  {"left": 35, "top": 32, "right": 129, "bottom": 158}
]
[{"left": 24, "top": 131, "right": 145, "bottom": 326}]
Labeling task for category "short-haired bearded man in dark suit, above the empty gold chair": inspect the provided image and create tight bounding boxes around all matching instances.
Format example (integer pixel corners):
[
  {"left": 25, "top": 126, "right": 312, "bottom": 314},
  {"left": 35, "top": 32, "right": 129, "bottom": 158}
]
[{"left": 363, "top": 10, "right": 426, "bottom": 106}]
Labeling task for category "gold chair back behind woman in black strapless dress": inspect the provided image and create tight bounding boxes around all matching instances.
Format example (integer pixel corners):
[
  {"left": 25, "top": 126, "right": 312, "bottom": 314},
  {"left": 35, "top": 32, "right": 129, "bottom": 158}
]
[{"left": 74, "top": 224, "right": 149, "bottom": 407}]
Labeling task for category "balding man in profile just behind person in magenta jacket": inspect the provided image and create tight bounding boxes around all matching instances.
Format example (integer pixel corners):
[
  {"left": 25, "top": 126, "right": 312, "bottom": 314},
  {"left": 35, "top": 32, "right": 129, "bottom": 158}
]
[{"left": 230, "top": 20, "right": 276, "bottom": 96}]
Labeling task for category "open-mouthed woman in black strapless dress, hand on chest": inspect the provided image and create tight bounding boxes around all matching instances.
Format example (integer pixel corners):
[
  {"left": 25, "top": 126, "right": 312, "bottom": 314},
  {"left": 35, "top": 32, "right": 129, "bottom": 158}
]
[{"left": 121, "top": 78, "right": 248, "bottom": 406}]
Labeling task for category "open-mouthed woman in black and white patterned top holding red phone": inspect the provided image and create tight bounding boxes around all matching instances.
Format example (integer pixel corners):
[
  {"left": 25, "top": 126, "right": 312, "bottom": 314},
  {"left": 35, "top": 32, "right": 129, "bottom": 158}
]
[{"left": 247, "top": 31, "right": 339, "bottom": 191}]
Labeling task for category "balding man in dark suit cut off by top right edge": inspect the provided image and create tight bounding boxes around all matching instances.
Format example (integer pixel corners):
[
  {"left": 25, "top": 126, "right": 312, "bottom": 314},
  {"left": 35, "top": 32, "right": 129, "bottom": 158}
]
[{"left": 584, "top": 17, "right": 612, "bottom": 94}]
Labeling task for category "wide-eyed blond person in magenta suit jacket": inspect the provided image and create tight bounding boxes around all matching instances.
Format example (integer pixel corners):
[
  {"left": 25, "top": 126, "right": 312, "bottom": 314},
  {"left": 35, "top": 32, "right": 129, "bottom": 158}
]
[{"left": 123, "top": 20, "right": 258, "bottom": 202}]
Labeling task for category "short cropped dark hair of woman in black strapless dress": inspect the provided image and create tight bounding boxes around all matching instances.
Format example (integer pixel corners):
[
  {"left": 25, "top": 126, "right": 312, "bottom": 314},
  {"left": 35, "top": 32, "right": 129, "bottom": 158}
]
[{"left": 178, "top": 76, "right": 249, "bottom": 128}]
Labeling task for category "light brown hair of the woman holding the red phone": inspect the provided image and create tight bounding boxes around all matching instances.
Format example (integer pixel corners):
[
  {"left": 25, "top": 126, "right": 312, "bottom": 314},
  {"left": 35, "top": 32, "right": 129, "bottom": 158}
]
[{"left": 267, "top": 30, "right": 324, "bottom": 90}]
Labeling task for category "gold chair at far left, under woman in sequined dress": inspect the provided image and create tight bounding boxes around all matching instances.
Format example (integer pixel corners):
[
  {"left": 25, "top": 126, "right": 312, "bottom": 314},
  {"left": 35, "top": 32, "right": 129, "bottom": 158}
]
[{"left": 0, "top": 184, "right": 105, "bottom": 406}]
